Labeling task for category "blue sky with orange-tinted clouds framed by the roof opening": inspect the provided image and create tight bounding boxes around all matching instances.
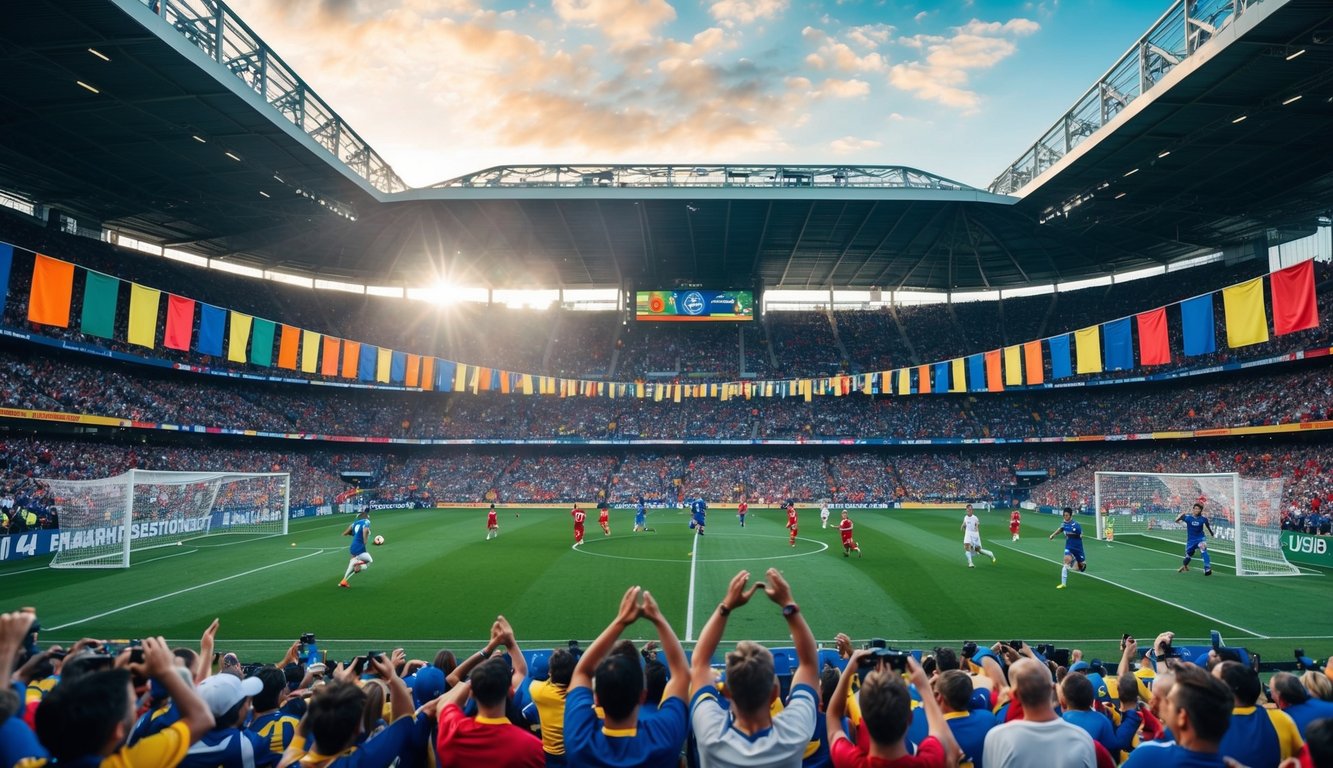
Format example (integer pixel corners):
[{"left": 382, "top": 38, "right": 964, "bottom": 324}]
[{"left": 231, "top": 0, "right": 1169, "bottom": 187}]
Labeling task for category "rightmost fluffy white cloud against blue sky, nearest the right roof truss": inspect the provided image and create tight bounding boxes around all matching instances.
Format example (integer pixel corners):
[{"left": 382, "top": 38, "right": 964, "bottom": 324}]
[{"left": 889, "top": 19, "right": 1041, "bottom": 113}]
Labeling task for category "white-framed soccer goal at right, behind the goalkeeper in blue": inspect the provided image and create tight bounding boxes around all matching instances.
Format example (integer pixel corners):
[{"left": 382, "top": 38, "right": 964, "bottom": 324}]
[{"left": 1096, "top": 472, "right": 1300, "bottom": 576}]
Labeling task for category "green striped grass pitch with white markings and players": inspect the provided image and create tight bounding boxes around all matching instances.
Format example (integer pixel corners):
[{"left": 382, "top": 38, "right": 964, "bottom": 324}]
[{"left": 0, "top": 508, "right": 1333, "bottom": 660}]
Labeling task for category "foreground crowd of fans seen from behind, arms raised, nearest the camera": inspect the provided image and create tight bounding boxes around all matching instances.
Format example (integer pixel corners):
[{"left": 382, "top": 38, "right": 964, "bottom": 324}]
[{"left": 0, "top": 592, "right": 1333, "bottom": 768}]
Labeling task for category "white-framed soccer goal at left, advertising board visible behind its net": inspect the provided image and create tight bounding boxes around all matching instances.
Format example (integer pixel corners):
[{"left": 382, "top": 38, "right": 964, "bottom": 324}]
[{"left": 39, "top": 469, "right": 291, "bottom": 568}]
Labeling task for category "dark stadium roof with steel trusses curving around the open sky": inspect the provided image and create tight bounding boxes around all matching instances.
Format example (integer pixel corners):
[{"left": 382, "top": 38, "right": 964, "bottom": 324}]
[{"left": 0, "top": 0, "right": 1333, "bottom": 289}]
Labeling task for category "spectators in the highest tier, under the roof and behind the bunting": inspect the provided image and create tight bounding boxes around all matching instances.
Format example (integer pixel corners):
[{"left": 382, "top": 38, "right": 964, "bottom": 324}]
[{"left": 0, "top": 206, "right": 1333, "bottom": 381}]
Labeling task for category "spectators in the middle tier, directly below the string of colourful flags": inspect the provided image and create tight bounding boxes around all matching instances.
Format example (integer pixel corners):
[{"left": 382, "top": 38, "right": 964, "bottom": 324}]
[{"left": 0, "top": 347, "right": 1333, "bottom": 441}]
